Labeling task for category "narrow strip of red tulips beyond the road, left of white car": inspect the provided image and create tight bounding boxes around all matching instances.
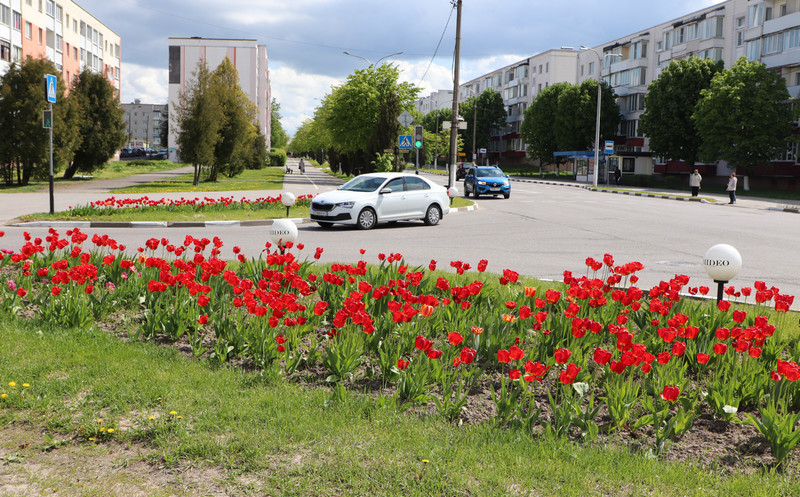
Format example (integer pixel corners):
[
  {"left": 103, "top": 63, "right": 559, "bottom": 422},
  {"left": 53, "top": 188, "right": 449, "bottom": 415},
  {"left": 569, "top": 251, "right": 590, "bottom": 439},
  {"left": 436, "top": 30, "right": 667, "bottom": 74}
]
[{"left": 62, "top": 195, "right": 313, "bottom": 217}]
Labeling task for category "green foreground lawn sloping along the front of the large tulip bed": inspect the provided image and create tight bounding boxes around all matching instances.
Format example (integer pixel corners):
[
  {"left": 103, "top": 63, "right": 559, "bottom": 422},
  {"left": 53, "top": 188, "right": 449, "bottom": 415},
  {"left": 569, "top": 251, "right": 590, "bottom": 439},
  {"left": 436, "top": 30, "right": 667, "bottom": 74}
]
[{"left": 0, "top": 317, "right": 795, "bottom": 496}]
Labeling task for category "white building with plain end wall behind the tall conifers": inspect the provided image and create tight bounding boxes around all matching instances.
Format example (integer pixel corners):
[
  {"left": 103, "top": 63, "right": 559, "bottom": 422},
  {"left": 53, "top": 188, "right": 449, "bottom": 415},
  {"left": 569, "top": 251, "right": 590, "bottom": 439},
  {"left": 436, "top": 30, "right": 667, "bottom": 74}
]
[{"left": 169, "top": 37, "right": 272, "bottom": 160}]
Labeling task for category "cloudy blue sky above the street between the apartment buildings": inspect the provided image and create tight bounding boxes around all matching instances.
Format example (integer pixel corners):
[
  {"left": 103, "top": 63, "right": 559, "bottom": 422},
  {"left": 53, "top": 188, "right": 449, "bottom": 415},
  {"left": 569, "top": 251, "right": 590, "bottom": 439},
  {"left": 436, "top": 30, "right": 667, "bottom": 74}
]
[{"left": 77, "top": 0, "right": 721, "bottom": 134}]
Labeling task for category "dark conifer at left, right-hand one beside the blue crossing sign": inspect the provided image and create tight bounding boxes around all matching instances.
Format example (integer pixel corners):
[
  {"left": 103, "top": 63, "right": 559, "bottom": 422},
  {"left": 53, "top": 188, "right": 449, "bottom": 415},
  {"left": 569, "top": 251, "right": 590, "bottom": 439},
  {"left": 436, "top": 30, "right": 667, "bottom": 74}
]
[{"left": 64, "top": 69, "right": 125, "bottom": 178}]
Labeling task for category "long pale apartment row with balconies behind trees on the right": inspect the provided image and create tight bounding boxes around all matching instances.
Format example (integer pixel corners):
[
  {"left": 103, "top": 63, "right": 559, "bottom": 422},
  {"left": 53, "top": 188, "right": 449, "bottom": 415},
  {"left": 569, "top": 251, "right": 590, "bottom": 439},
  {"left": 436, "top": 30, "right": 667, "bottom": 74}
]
[{"left": 459, "top": 0, "right": 800, "bottom": 188}]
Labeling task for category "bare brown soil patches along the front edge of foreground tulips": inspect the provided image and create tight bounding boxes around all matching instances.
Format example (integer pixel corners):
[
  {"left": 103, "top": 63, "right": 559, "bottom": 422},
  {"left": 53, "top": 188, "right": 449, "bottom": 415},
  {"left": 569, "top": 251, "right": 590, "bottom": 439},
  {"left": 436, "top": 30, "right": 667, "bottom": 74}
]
[{"left": 97, "top": 308, "right": 800, "bottom": 476}]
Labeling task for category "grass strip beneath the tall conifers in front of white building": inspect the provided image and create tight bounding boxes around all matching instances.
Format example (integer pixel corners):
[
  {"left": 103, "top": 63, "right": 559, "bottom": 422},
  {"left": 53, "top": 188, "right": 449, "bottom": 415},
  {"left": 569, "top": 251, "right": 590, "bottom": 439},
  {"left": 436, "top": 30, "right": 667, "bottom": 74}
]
[{"left": 112, "top": 167, "right": 284, "bottom": 193}]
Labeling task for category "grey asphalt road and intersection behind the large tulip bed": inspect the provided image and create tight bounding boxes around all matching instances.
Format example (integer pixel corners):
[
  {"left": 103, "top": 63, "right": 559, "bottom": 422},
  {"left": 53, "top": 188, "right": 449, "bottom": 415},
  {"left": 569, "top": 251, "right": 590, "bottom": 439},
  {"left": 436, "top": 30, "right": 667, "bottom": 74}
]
[{"left": 0, "top": 160, "right": 800, "bottom": 296}]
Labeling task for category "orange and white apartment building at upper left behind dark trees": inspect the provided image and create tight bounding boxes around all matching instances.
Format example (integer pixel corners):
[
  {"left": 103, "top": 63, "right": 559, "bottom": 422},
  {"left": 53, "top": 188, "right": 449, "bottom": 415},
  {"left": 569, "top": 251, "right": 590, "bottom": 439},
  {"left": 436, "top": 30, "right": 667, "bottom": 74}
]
[{"left": 0, "top": 0, "right": 121, "bottom": 92}]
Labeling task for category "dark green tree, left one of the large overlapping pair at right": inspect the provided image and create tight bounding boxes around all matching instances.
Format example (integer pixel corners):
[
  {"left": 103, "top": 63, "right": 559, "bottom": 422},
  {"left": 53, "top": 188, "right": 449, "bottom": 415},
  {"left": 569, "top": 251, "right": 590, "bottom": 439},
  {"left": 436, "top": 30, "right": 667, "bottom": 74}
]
[{"left": 639, "top": 57, "right": 724, "bottom": 170}]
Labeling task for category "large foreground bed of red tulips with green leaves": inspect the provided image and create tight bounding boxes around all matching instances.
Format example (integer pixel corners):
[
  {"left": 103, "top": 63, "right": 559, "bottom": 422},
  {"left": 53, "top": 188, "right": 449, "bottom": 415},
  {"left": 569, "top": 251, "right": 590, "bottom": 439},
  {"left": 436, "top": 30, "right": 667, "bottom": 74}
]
[{"left": 0, "top": 229, "right": 800, "bottom": 470}]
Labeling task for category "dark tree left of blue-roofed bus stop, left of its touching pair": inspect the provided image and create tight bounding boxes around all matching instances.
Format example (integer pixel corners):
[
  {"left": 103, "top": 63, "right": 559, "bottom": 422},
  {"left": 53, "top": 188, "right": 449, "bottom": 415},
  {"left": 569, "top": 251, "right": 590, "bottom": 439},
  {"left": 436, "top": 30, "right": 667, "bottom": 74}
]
[{"left": 520, "top": 83, "right": 572, "bottom": 164}]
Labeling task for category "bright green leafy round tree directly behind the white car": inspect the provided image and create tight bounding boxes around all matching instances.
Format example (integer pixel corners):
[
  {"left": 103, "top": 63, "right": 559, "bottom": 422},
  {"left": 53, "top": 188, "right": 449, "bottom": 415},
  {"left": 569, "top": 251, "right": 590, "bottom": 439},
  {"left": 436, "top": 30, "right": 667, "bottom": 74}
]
[{"left": 325, "top": 64, "right": 419, "bottom": 172}]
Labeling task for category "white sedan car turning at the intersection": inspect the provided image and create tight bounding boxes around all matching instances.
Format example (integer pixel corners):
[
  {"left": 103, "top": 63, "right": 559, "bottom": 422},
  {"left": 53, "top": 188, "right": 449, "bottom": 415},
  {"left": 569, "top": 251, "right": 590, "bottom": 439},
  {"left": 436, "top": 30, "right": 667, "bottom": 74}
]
[{"left": 310, "top": 173, "right": 450, "bottom": 230}]
